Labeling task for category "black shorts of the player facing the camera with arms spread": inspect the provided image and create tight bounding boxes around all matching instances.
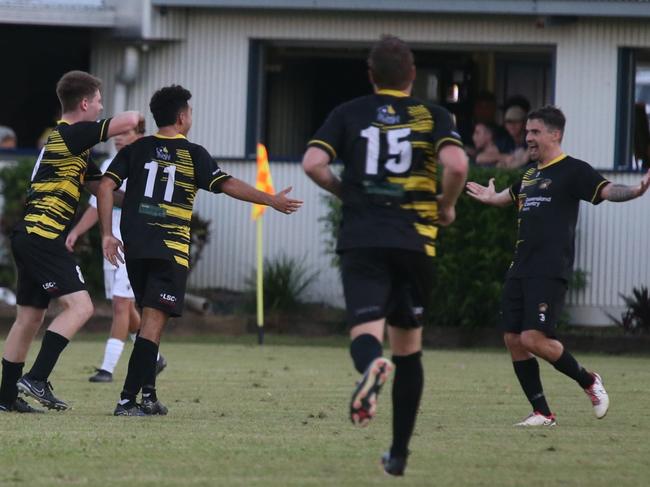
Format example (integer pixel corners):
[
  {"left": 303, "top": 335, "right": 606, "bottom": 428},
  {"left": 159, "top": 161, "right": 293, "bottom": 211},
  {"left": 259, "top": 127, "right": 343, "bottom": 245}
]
[{"left": 501, "top": 278, "right": 567, "bottom": 338}]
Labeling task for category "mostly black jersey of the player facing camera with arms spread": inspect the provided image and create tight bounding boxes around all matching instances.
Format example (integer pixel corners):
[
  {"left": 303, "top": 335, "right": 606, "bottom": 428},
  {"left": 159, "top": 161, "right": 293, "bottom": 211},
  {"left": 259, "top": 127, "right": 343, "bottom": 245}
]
[{"left": 508, "top": 154, "right": 608, "bottom": 279}]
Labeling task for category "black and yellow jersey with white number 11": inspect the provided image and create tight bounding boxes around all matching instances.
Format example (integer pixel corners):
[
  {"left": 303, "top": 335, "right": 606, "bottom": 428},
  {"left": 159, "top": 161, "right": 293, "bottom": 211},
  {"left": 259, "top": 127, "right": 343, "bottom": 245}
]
[{"left": 104, "top": 134, "right": 230, "bottom": 267}]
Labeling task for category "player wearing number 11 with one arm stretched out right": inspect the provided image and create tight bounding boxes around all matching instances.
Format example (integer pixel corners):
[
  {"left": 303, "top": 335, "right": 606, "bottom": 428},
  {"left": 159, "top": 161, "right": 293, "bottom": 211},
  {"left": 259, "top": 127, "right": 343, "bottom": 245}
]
[{"left": 97, "top": 85, "right": 302, "bottom": 416}]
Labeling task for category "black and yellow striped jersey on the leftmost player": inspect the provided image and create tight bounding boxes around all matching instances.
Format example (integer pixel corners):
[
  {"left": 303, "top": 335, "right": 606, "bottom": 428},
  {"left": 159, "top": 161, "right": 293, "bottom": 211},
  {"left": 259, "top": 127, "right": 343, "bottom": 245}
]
[{"left": 16, "top": 119, "right": 110, "bottom": 240}]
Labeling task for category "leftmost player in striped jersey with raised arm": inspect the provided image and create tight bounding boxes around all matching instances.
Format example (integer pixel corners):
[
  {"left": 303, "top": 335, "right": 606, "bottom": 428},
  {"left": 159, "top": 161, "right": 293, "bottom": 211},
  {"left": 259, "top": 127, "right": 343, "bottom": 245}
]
[{"left": 0, "top": 71, "right": 141, "bottom": 412}]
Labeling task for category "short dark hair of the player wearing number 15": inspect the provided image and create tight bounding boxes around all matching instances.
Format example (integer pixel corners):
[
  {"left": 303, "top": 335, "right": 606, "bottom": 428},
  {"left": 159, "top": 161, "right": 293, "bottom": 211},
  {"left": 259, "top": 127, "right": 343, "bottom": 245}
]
[{"left": 368, "top": 35, "right": 414, "bottom": 89}]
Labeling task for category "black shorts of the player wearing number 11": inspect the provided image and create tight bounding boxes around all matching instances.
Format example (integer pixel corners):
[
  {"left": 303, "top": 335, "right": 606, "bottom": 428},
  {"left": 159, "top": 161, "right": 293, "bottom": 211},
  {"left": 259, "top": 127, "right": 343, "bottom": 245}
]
[{"left": 126, "top": 259, "right": 187, "bottom": 316}]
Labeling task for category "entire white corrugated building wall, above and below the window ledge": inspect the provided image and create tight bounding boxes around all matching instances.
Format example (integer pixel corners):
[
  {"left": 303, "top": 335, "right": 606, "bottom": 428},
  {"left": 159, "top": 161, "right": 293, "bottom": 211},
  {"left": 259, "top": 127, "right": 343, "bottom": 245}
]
[{"left": 92, "top": 10, "right": 650, "bottom": 323}]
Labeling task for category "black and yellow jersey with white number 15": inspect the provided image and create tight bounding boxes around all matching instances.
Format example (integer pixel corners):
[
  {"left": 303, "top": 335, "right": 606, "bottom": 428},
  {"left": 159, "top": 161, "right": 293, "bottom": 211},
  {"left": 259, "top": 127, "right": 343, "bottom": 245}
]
[{"left": 308, "top": 90, "right": 463, "bottom": 256}]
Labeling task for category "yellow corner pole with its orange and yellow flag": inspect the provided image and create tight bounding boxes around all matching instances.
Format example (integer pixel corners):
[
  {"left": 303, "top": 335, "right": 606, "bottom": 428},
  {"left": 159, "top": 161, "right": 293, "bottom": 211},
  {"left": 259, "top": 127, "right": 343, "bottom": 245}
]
[{"left": 251, "top": 144, "right": 275, "bottom": 345}]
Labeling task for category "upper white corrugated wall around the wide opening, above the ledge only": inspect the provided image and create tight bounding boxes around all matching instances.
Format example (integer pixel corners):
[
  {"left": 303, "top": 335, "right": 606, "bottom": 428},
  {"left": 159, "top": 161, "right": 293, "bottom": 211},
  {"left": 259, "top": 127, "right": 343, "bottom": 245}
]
[{"left": 92, "top": 9, "right": 650, "bottom": 168}]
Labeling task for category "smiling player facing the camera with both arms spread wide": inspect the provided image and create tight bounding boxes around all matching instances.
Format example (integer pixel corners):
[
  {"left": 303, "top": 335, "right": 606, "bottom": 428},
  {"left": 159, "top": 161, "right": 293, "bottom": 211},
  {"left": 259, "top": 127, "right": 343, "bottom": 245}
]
[{"left": 467, "top": 106, "right": 650, "bottom": 426}]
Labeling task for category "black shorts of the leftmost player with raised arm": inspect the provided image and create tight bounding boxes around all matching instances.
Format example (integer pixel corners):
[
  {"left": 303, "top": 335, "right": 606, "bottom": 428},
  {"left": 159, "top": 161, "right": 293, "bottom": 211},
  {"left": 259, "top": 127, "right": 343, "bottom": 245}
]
[{"left": 11, "top": 232, "right": 86, "bottom": 309}]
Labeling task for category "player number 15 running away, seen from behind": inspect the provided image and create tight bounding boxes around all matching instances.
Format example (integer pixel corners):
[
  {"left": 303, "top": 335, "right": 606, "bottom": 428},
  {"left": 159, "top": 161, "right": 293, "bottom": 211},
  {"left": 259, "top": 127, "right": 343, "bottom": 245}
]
[{"left": 303, "top": 36, "right": 467, "bottom": 475}]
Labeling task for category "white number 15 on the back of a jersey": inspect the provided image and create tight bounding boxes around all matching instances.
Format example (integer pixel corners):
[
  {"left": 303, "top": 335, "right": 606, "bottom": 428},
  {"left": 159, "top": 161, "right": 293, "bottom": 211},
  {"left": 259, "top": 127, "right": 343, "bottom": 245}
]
[{"left": 361, "top": 126, "right": 413, "bottom": 175}]
